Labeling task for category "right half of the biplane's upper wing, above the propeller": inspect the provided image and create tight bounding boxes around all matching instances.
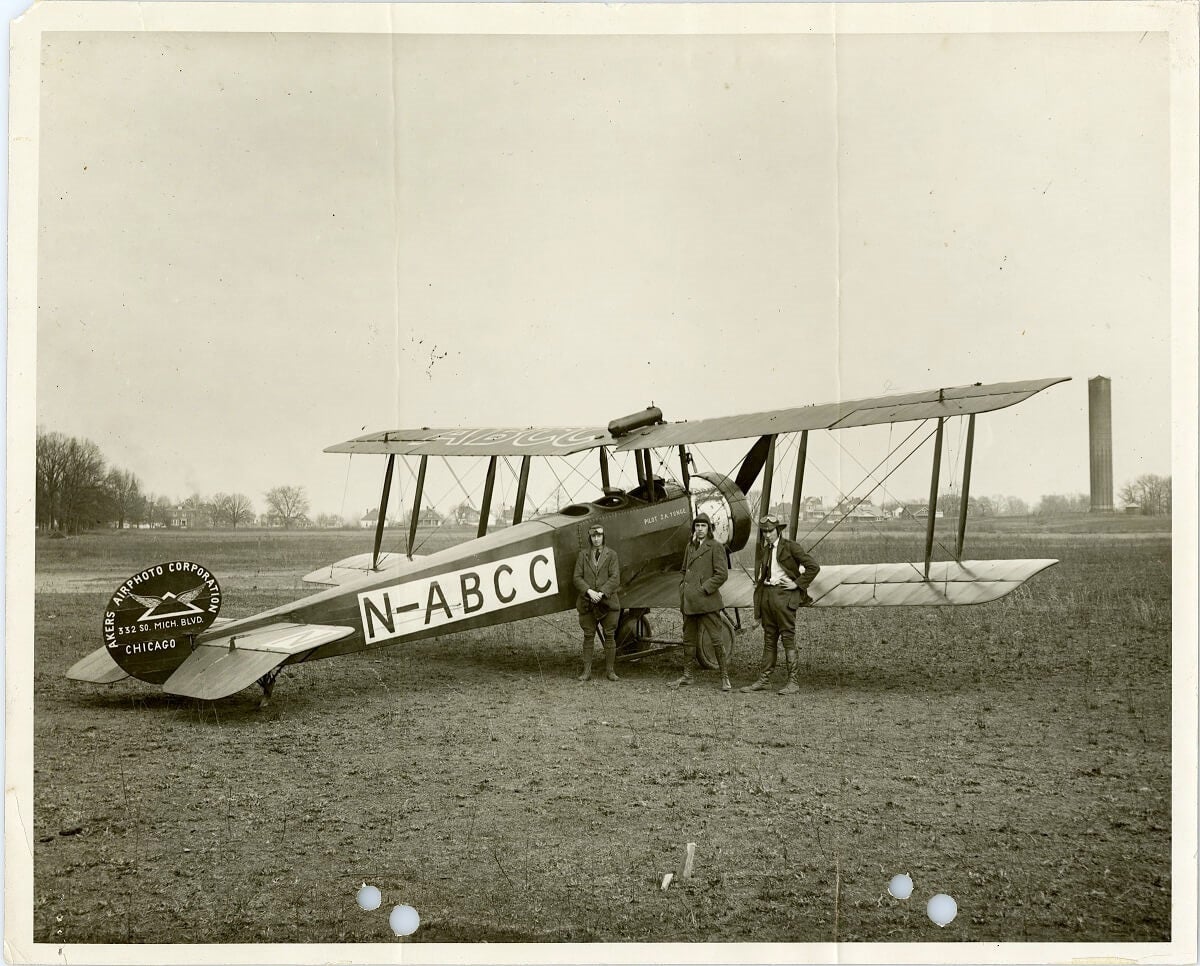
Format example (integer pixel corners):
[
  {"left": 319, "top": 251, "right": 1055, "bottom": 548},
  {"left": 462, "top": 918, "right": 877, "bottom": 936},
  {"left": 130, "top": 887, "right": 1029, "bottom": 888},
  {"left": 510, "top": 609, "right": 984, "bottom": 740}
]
[{"left": 617, "top": 377, "right": 1070, "bottom": 452}]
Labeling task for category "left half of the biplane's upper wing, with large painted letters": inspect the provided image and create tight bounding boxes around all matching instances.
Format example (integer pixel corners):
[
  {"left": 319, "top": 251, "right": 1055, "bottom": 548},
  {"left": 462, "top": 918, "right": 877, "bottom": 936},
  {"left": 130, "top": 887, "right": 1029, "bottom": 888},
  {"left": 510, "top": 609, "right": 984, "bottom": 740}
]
[{"left": 325, "top": 426, "right": 617, "bottom": 456}]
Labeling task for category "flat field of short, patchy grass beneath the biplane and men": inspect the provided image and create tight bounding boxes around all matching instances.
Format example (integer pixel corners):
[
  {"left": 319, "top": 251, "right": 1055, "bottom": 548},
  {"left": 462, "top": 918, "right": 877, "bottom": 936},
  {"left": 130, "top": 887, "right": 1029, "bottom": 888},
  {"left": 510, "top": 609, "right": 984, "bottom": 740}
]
[{"left": 30, "top": 520, "right": 1171, "bottom": 943}]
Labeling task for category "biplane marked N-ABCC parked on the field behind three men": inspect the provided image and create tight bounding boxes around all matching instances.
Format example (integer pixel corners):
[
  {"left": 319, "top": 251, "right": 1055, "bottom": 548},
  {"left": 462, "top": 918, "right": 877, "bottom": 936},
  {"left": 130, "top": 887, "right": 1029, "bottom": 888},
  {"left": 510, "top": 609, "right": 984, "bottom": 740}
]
[{"left": 67, "top": 378, "right": 1066, "bottom": 703}]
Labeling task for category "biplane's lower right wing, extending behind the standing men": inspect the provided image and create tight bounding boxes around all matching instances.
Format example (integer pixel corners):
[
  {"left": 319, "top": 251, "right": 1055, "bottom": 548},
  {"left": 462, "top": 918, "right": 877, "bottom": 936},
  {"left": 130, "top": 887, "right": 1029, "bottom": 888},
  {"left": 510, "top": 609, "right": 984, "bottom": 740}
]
[{"left": 620, "top": 559, "right": 1058, "bottom": 607}]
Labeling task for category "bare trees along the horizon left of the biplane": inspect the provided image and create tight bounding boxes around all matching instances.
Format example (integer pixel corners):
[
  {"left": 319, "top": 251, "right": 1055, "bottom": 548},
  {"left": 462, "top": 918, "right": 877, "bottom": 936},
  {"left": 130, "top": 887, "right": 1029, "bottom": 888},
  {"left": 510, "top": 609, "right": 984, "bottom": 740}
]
[{"left": 35, "top": 428, "right": 321, "bottom": 534}]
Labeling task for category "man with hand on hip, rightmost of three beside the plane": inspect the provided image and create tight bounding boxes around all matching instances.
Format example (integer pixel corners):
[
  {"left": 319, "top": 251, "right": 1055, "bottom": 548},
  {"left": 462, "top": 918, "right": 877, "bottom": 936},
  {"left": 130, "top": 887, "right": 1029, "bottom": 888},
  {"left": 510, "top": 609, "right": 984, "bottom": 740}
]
[{"left": 740, "top": 514, "right": 821, "bottom": 695}]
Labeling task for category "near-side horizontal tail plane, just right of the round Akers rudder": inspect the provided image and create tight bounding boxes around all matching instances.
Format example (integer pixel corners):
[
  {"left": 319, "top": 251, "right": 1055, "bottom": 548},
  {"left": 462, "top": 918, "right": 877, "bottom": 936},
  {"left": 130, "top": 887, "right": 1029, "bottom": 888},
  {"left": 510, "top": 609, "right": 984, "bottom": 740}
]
[{"left": 162, "top": 624, "right": 354, "bottom": 701}]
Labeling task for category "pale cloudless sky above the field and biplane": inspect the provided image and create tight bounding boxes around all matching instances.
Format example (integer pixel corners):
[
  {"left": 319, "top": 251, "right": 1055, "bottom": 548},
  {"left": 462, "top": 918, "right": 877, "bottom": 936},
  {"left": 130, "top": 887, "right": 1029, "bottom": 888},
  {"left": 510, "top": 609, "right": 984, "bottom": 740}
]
[{"left": 36, "top": 22, "right": 1171, "bottom": 517}]
